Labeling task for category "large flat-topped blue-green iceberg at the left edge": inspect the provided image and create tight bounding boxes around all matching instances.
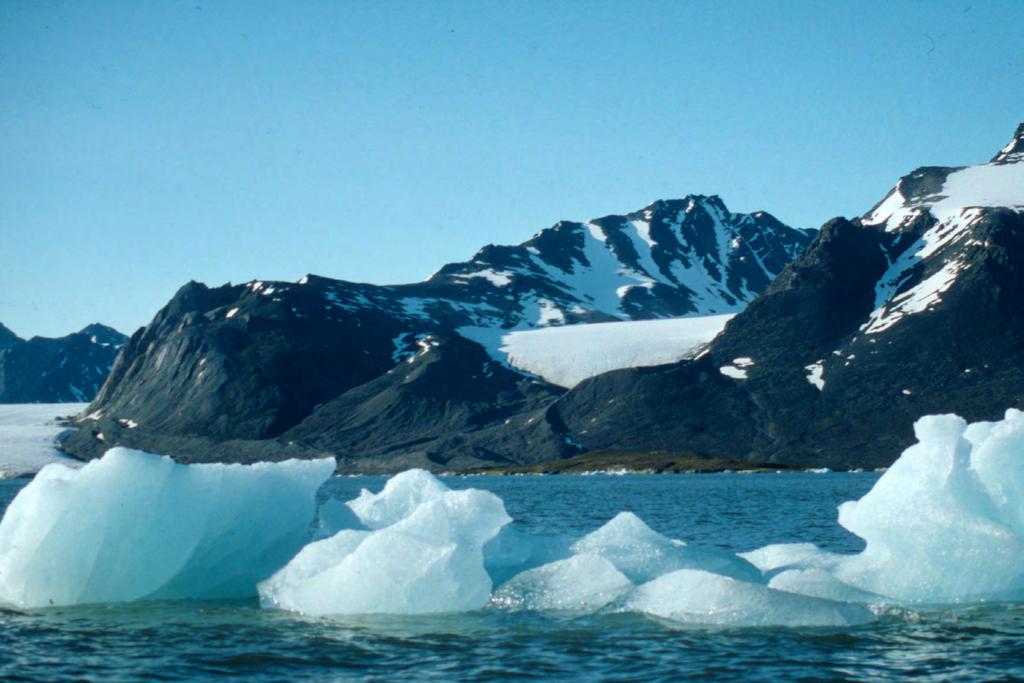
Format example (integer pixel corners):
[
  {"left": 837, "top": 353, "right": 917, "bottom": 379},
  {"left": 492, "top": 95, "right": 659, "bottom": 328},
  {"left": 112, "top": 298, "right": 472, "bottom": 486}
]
[{"left": 0, "top": 449, "right": 335, "bottom": 608}]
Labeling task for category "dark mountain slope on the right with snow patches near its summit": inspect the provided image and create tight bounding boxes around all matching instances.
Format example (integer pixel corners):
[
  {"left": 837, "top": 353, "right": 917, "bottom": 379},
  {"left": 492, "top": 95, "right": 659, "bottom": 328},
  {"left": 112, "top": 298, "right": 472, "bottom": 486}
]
[{"left": 552, "top": 125, "right": 1024, "bottom": 467}]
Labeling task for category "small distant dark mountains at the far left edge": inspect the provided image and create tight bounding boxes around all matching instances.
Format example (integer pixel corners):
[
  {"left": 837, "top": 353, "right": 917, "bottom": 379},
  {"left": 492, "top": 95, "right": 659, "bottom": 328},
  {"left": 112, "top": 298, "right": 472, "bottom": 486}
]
[{"left": 0, "top": 324, "right": 128, "bottom": 403}]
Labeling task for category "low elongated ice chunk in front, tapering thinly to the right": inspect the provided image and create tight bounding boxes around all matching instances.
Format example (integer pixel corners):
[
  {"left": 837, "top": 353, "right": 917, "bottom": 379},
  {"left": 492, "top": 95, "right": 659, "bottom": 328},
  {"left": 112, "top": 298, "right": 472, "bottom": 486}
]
[{"left": 624, "top": 569, "right": 874, "bottom": 627}]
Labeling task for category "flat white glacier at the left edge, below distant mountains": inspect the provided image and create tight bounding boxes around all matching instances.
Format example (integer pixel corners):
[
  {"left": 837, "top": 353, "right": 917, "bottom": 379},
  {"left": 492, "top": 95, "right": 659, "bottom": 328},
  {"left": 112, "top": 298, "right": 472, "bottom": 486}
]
[{"left": 0, "top": 403, "right": 88, "bottom": 479}]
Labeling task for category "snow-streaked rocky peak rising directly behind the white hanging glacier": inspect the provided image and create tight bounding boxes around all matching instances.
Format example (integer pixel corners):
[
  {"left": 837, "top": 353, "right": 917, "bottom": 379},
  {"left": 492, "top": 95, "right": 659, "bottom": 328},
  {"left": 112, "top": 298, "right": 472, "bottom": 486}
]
[{"left": 426, "top": 196, "right": 813, "bottom": 329}]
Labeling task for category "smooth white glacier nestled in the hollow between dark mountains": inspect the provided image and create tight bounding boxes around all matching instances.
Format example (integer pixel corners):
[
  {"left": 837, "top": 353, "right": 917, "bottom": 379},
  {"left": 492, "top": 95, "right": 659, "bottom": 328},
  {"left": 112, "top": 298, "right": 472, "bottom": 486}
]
[{"left": 459, "top": 313, "right": 732, "bottom": 388}]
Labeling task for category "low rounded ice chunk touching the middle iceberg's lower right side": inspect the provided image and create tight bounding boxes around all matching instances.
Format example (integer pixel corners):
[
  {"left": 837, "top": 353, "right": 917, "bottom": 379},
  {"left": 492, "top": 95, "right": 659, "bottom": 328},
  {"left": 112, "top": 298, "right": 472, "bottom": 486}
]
[{"left": 492, "top": 555, "right": 633, "bottom": 611}]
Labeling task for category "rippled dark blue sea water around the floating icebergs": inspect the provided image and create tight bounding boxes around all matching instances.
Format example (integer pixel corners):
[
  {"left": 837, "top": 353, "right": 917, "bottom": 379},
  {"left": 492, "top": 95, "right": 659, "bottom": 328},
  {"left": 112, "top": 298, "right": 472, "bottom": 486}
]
[{"left": 6, "top": 473, "right": 1024, "bottom": 681}]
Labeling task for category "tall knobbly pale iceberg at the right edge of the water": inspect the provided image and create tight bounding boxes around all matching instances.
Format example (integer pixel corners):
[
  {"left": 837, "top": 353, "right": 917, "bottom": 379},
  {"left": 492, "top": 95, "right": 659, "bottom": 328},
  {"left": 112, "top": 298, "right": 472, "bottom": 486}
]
[{"left": 836, "top": 410, "right": 1024, "bottom": 603}]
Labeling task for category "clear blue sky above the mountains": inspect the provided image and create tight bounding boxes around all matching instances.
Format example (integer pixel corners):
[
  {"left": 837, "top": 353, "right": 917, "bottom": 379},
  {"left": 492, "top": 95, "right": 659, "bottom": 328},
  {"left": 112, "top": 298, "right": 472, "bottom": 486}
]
[{"left": 0, "top": 0, "right": 1024, "bottom": 336}]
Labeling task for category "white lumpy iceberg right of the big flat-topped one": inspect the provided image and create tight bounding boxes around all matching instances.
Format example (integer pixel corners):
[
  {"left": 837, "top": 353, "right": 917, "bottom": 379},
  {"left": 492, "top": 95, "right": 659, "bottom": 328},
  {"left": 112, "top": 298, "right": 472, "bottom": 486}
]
[{"left": 259, "top": 470, "right": 512, "bottom": 615}]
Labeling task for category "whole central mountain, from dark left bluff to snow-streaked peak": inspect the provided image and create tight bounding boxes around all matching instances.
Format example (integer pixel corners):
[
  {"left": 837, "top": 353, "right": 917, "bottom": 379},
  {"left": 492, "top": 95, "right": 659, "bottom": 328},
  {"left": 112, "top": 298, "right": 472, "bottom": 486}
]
[{"left": 65, "top": 196, "right": 813, "bottom": 470}]
